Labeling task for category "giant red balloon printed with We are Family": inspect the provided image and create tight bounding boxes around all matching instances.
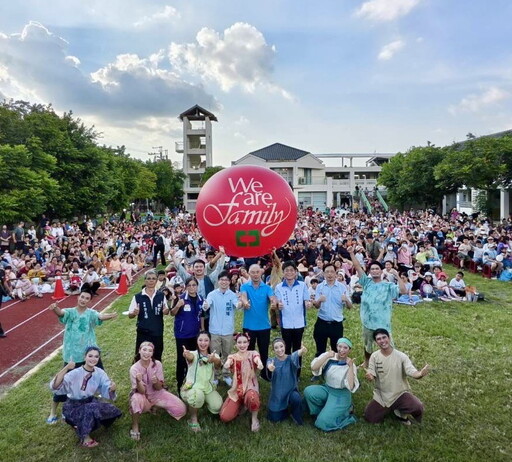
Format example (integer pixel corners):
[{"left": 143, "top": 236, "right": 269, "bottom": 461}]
[{"left": 196, "top": 165, "right": 297, "bottom": 257}]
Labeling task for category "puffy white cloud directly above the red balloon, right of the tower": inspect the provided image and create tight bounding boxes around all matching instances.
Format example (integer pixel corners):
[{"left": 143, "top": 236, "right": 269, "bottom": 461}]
[{"left": 169, "top": 22, "right": 293, "bottom": 99}]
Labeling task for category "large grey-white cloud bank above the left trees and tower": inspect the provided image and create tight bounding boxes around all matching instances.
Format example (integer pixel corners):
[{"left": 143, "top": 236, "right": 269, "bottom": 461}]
[{"left": 0, "top": 22, "right": 218, "bottom": 124}]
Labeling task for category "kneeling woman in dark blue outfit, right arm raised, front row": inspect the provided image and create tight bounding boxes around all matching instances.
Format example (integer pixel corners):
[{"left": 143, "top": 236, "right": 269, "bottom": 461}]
[{"left": 267, "top": 338, "right": 307, "bottom": 425}]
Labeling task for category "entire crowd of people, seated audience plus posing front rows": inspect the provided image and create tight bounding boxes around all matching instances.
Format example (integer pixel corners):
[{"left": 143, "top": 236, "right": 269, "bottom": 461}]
[{"left": 2, "top": 209, "right": 512, "bottom": 447}]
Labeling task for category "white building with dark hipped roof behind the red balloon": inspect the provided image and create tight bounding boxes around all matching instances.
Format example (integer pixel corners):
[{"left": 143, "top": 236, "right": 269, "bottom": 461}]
[{"left": 232, "top": 143, "right": 394, "bottom": 210}]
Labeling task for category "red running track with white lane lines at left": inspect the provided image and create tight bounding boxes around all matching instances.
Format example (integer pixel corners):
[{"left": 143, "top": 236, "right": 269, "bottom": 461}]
[{"left": 0, "top": 289, "right": 119, "bottom": 392}]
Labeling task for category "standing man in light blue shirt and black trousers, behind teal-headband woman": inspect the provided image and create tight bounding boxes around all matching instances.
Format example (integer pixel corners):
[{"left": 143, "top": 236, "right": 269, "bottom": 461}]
[{"left": 313, "top": 263, "right": 352, "bottom": 356}]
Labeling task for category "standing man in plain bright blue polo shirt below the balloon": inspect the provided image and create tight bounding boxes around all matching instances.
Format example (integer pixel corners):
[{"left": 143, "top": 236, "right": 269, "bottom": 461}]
[{"left": 240, "top": 264, "right": 277, "bottom": 381}]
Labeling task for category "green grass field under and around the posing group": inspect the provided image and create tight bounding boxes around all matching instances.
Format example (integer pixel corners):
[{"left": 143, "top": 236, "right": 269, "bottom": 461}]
[{"left": 0, "top": 267, "right": 512, "bottom": 462}]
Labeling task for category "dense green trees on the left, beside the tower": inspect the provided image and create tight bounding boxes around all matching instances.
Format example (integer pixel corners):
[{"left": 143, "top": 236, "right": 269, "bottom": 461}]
[{"left": 0, "top": 101, "right": 183, "bottom": 223}]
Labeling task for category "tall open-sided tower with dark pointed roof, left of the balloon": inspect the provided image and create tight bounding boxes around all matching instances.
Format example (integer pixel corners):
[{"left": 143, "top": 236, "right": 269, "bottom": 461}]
[{"left": 176, "top": 104, "right": 217, "bottom": 212}]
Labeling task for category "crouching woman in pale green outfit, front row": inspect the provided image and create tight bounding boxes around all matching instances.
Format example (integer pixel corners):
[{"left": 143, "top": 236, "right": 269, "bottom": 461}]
[{"left": 178, "top": 331, "right": 222, "bottom": 432}]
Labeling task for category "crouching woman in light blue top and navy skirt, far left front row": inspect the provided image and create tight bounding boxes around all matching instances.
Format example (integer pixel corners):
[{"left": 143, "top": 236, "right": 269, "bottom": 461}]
[{"left": 50, "top": 347, "right": 122, "bottom": 448}]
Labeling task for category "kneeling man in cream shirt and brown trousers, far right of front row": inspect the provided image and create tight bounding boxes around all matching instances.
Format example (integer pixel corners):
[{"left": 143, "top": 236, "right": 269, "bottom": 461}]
[{"left": 364, "top": 329, "right": 430, "bottom": 425}]
